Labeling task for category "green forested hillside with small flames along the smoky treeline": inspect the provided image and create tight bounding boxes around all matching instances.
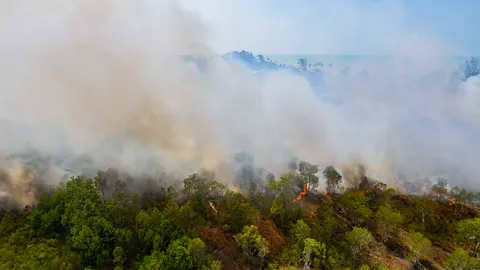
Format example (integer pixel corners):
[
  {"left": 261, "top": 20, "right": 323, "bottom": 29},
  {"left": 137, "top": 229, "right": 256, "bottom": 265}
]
[{"left": 0, "top": 159, "right": 480, "bottom": 270}]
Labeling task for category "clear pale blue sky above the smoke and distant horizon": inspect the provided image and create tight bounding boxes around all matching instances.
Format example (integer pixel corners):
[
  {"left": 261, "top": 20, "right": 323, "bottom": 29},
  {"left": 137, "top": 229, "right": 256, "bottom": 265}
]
[{"left": 182, "top": 0, "right": 480, "bottom": 56}]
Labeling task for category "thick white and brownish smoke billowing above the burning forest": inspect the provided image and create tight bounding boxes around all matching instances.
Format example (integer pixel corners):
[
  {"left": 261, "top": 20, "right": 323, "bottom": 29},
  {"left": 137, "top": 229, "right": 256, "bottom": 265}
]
[{"left": 0, "top": 0, "right": 480, "bottom": 207}]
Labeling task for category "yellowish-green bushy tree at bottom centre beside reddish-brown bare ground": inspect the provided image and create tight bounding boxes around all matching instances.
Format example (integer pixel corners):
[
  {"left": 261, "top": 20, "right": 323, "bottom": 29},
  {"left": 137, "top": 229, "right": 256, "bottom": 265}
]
[{"left": 235, "top": 225, "right": 270, "bottom": 266}]
